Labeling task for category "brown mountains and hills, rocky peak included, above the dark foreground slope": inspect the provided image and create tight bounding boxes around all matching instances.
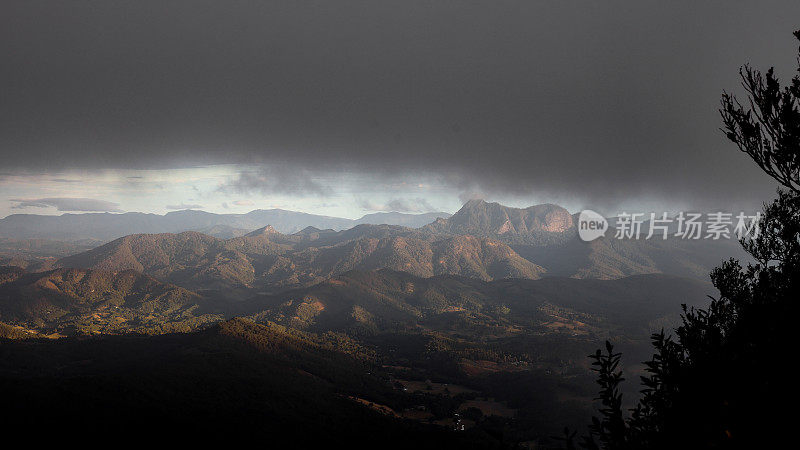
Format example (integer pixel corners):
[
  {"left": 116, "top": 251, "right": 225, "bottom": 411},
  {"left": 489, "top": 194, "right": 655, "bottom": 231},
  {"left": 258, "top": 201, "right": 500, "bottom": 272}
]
[{"left": 0, "top": 201, "right": 737, "bottom": 342}]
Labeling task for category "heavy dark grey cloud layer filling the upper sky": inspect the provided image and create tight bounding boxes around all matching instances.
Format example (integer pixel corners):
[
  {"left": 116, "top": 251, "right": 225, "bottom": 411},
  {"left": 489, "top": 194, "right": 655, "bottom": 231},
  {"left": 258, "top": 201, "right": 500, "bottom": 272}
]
[{"left": 0, "top": 0, "right": 800, "bottom": 208}]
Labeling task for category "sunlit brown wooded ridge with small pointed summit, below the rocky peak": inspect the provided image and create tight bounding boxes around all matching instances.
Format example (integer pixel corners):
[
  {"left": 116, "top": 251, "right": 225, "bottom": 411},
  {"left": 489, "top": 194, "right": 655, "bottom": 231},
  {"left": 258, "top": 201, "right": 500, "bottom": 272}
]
[{"left": 56, "top": 225, "right": 544, "bottom": 289}]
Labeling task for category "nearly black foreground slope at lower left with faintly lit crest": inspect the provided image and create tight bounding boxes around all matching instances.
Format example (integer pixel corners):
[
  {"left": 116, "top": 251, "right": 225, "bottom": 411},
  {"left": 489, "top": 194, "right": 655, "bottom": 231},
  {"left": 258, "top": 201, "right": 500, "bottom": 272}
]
[{"left": 0, "top": 319, "right": 502, "bottom": 448}]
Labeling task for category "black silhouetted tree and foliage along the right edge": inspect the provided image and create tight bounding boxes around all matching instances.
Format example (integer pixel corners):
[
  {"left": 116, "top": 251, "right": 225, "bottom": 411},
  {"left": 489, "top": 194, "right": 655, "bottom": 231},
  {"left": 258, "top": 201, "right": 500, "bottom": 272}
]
[{"left": 570, "top": 31, "right": 800, "bottom": 449}]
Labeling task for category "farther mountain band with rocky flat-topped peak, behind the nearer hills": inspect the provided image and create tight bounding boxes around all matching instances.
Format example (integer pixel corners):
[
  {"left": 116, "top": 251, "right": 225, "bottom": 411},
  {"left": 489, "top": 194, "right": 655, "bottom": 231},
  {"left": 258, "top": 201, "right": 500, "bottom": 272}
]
[{"left": 0, "top": 200, "right": 744, "bottom": 292}]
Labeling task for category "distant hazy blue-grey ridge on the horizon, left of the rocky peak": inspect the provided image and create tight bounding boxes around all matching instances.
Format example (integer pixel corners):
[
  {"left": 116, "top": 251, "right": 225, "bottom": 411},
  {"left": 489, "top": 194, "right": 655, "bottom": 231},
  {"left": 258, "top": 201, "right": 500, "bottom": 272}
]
[{"left": 0, "top": 209, "right": 449, "bottom": 242}]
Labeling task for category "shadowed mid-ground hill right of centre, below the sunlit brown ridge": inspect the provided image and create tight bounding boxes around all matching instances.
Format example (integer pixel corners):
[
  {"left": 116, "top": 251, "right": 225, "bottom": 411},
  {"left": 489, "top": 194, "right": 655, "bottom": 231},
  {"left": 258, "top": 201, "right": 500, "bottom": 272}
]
[{"left": 237, "top": 269, "right": 713, "bottom": 338}]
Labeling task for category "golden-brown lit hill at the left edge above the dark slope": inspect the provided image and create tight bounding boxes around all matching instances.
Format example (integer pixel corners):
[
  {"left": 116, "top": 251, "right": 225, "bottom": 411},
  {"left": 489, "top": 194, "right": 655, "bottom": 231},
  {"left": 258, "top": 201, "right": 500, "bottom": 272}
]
[{"left": 0, "top": 267, "right": 222, "bottom": 334}]
